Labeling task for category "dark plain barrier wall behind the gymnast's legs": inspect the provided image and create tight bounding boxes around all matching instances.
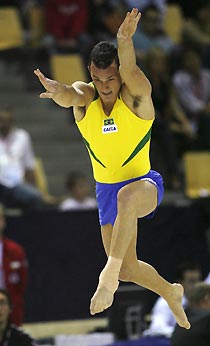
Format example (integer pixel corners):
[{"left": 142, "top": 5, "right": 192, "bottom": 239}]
[{"left": 5, "top": 204, "right": 210, "bottom": 322}]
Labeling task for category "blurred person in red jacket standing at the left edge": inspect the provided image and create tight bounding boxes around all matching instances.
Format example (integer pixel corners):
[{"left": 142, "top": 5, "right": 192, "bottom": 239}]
[{"left": 0, "top": 205, "right": 28, "bottom": 326}]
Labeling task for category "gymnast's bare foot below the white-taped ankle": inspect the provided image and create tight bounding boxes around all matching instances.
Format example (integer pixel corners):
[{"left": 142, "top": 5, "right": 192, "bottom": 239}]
[{"left": 90, "top": 287, "right": 114, "bottom": 315}]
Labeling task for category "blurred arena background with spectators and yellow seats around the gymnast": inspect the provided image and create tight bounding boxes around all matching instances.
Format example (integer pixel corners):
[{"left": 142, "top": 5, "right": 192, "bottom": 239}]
[{"left": 0, "top": 0, "right": 210, "bottom": 346}]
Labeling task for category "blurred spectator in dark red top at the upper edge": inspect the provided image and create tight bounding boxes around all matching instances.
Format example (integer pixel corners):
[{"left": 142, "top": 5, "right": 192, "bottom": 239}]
[{"left": 46, "top": 0, "right": 89, "bottom": 52}]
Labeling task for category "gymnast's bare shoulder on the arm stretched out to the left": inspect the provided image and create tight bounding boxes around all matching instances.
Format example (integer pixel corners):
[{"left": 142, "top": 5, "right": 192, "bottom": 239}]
[{"left": 72, "top": 81, "right": 95, "bottom": 121}]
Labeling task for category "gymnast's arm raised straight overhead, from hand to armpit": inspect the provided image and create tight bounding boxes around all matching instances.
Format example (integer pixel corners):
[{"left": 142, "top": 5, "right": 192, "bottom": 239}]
[{"left": 117, "top": 8, "right": 155, "bottom": 120}]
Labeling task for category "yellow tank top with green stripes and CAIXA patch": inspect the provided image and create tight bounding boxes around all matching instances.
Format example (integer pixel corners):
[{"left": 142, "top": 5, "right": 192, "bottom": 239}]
[{"left": 76, "top": 92, "right": 153, "bottom": 183}]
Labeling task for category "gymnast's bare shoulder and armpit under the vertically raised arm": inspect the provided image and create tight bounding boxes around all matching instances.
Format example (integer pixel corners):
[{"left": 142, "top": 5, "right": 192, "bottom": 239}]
[{"left": 121, "top": 83, "right": 155, "bottom": 120}]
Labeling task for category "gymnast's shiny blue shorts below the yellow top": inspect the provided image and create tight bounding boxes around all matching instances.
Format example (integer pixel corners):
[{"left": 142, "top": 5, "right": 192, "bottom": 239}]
[{"left": 96, "top": 170, "right": 164, "bottom": 226}]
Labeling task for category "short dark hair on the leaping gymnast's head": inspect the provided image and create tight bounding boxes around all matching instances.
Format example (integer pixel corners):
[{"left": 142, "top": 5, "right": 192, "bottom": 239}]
[{"left": 89, "top": 41, "right": 119, "bottom": 69}]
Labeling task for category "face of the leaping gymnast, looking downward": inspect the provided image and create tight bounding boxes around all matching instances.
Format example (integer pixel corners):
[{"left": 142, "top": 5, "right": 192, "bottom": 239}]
[{"left": 89, "top": 61, "right": 122, "bottom": 104}]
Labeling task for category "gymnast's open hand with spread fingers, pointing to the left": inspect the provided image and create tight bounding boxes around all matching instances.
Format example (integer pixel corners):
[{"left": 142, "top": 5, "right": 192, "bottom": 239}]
[{"left": 34, "top": 69, "right": 65, "bottom": 102}]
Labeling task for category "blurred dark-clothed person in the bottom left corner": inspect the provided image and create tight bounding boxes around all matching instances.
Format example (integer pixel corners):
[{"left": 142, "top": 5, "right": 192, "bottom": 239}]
[{"left": 0, "top": 289, "right": 35, "bottom": 346}]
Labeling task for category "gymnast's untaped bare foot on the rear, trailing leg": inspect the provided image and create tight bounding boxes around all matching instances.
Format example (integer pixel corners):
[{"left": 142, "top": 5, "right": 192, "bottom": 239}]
[{"left": 165, "top": 284, "right": 190, "bottom": 329}]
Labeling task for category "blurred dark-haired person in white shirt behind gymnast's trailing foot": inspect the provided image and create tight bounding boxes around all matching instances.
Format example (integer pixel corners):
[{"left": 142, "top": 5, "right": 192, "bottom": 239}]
[{"left": 145, "top": 263, "right": 201, "bottom": 336}]
